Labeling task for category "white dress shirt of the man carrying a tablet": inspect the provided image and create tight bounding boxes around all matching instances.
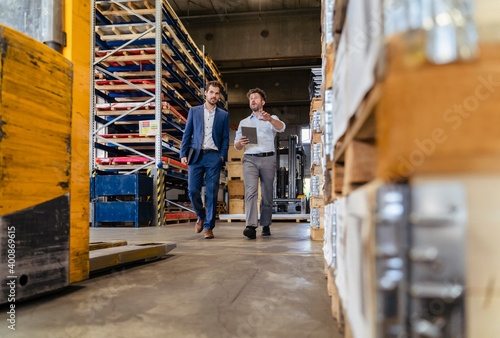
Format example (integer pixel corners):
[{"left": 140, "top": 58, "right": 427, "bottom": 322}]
[{"left": 234, "top": 113, "right": 286, "bottom": 154}]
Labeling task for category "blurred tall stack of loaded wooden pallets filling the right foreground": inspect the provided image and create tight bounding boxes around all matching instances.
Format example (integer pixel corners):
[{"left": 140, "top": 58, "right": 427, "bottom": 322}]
[{"left": 322, "top": 0, "right": 500, "bottom": 338}]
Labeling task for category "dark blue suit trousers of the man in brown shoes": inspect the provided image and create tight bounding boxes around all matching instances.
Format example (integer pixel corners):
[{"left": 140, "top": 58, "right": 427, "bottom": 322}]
[{"left": 188, "top": 153, "right": 222, "bottom": 230}]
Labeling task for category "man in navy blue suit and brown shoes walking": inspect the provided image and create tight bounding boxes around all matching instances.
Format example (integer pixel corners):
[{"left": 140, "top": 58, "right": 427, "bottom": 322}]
[{"left": 180, "top": 81, "right": 229, "bottom": 239}]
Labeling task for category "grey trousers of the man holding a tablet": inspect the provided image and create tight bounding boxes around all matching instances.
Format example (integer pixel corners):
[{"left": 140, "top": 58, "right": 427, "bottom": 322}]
[{"left": 243, "top": 155, "right": 276, "bottom": 227}]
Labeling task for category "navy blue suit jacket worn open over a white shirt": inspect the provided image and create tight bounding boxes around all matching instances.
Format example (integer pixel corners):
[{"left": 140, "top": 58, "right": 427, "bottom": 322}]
[{"left": 180, "top": 104, "right": 229, "bottom": 163}]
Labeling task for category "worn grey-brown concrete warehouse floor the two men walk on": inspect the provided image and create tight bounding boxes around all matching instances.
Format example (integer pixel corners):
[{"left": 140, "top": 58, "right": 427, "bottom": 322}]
[{"left": 0, "top": 222, "right": 341, "bottom": 338}]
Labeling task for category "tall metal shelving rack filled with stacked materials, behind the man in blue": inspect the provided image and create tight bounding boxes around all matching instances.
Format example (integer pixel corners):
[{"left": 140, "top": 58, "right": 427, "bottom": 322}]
[{"left": 90, "top": 0, "right": 227, "bottom": 226}]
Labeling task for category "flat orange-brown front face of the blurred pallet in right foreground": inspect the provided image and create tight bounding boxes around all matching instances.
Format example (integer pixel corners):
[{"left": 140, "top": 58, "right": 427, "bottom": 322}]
[{"left": 375, "top": 39, "right": 500, "bottom": 180}]
